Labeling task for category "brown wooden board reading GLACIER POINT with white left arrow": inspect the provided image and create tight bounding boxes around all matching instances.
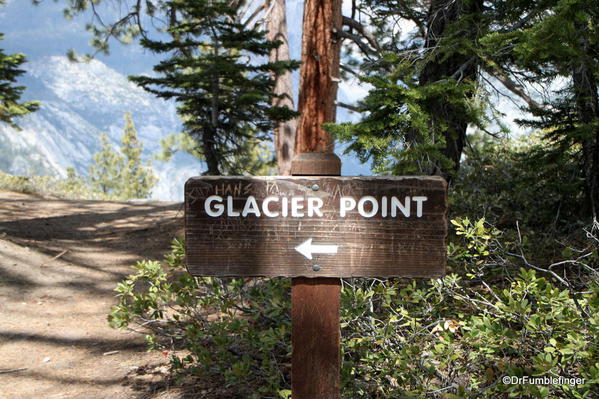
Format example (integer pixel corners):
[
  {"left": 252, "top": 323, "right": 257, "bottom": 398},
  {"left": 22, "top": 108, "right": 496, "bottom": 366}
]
[{"left": 185, "top": 176, "right": 447, "bottom": 278}]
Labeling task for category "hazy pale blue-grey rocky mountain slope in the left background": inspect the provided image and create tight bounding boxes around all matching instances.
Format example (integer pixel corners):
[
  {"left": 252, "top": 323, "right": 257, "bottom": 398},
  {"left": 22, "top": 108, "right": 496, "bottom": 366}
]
[{"left": 0, "top": 56, "right": 202, "bottom": 200}]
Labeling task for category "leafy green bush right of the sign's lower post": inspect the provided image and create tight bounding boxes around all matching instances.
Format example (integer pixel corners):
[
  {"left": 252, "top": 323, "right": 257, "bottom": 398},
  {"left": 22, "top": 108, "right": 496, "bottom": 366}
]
[{"left": 343, "top": 219, "right": 599, "bottom": 398}]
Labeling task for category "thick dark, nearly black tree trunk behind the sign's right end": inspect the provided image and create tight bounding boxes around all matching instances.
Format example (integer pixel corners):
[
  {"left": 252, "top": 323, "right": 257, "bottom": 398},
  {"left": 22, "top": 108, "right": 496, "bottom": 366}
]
[{"left": 419, "top": 0, "right": 483, "bottom": 182}]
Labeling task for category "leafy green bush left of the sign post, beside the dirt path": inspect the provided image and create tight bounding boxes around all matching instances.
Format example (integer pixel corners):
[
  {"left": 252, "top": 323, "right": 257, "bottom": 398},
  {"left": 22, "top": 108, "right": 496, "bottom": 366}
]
[{"left": 109, "top": 239, "right": 291, "bottom": 398}]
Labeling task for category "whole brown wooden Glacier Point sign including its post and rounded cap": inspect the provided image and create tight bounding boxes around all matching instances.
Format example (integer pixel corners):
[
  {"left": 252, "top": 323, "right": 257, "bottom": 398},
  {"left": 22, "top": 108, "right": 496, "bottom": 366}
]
[{"left": 185, "top": 171, "right": 447, "bottom": 399}]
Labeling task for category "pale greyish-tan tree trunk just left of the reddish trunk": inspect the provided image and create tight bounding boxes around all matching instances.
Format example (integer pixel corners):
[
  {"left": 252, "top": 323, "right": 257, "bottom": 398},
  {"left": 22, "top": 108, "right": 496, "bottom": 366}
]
[{"left": 266, "top": 0, "right": 297, "bottom": 175}]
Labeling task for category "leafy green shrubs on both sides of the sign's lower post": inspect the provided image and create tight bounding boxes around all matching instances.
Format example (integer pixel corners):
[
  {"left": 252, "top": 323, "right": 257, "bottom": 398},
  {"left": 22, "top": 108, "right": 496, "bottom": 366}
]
[{"left": 109, "top": 218, "right": 599, "bottom": 399}]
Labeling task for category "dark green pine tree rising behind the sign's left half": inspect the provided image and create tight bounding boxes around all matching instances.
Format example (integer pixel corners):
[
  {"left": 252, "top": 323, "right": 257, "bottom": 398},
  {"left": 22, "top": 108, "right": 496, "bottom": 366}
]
[{"left": 131, "top": 0, "right": 297, "bottom": 175}]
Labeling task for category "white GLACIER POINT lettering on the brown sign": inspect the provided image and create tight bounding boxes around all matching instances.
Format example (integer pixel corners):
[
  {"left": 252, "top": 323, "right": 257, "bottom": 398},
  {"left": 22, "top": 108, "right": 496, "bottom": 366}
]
[{"left": 204, "top": 195, "right": 428, "bottom": 218}]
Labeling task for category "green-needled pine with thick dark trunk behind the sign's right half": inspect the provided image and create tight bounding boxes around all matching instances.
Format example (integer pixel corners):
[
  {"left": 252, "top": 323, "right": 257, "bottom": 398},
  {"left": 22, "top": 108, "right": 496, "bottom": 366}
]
[{"left": 329, "top": 0, "right": 486, "bottom": 180}]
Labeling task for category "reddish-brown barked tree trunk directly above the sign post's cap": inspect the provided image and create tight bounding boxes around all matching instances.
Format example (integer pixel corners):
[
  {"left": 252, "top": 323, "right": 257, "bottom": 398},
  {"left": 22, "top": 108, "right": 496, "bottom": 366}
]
[{"left": 295, "top": 0, "right": 342, "bottom": 153}]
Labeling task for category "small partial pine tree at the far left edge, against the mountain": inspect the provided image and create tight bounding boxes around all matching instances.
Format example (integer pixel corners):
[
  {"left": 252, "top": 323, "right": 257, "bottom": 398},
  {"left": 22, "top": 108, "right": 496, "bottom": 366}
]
[{"left": 0, "top": 29, "right": 39, "bottom": 127}]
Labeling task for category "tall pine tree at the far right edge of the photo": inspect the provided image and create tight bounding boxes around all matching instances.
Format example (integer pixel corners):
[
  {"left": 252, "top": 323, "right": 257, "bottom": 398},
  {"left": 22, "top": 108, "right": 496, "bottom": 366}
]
[{"left": 482, "top": 0, "right": 599, "bottom": 217}]
